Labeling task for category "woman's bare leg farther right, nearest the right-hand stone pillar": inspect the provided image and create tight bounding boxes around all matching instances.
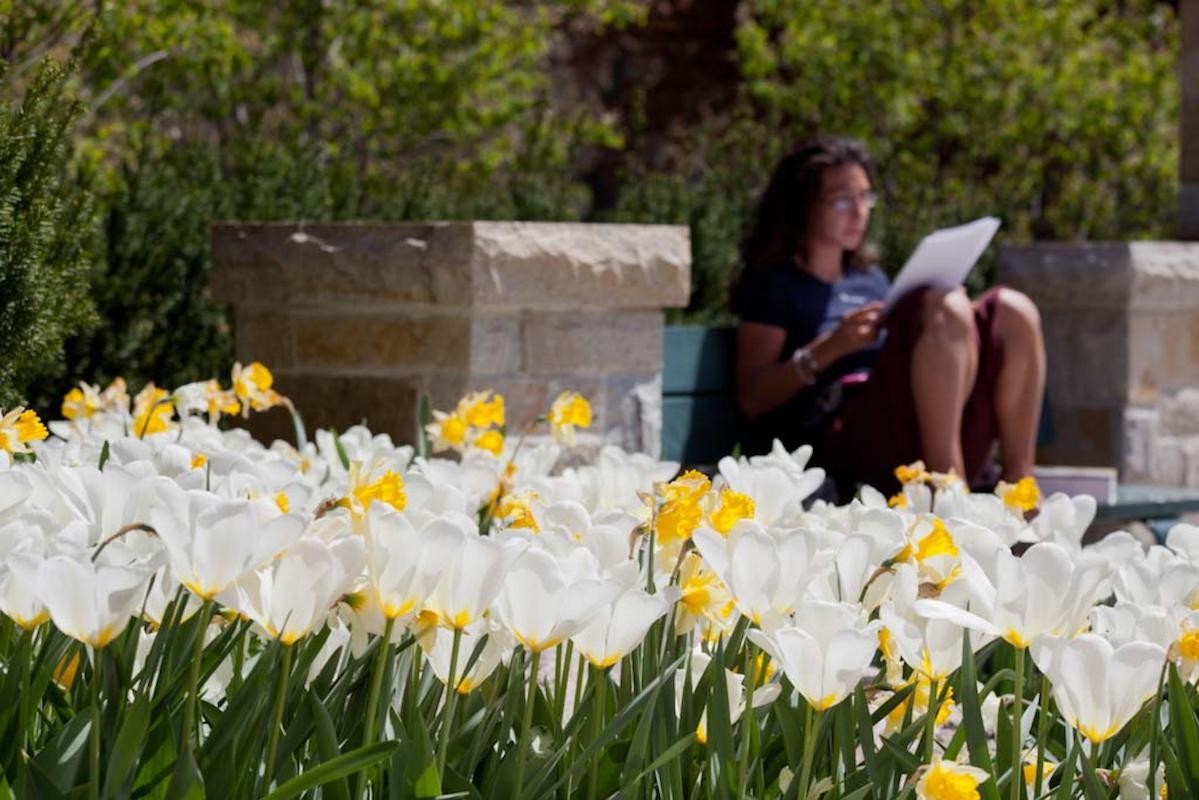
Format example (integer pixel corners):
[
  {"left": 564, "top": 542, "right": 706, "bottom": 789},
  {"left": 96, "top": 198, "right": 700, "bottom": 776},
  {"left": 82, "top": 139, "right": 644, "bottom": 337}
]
[{"left": 995, "top": 289, "right": 1046, "bottom": 481}]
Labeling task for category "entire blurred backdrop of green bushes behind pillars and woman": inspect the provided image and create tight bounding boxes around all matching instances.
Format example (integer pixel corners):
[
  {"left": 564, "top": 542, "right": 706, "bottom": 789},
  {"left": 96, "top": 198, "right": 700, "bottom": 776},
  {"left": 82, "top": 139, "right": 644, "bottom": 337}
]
[{"left": 0, "top": 0, "right": 1180, "bottom": 416}]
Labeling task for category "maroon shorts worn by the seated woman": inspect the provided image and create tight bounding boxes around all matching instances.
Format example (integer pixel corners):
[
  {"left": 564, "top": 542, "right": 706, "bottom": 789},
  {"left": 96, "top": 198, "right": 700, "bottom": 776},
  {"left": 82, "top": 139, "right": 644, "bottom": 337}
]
[{"left": 820, "top": 287, "right": 1004, "bottom": 495}]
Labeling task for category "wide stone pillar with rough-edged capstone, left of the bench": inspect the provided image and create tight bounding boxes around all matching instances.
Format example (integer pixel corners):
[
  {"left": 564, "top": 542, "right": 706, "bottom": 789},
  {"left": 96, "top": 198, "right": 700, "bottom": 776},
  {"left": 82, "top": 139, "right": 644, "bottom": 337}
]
[{"left": 212, "top": 222, "right": 691, "bottom": 452}]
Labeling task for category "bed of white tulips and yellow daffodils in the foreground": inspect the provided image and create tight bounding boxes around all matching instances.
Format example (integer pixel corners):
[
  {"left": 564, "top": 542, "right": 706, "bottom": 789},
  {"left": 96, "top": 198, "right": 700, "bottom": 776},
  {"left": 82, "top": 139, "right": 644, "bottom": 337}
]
[{"left": 0, "top": 363, "right": 1199, "bottom": 800}]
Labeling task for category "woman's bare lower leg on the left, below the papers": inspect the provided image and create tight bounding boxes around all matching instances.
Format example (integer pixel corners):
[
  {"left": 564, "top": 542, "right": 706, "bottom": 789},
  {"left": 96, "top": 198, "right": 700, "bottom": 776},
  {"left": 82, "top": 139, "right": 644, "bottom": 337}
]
[{"left": 911, "top": 289, "right": 978, "bottom": 477}]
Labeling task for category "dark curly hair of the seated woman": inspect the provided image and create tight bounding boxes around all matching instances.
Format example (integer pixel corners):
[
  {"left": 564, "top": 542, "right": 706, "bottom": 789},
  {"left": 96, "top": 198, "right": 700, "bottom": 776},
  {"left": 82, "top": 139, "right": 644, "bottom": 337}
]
[{"left": 741, "top": 137, "right": 876, "bottom": 277}]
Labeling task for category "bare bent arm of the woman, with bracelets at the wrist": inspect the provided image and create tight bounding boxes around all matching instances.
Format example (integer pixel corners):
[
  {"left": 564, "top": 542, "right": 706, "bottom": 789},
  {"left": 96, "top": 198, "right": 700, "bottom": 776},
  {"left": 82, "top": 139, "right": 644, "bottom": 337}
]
[{"left": 737, "top": 303, "right": 881, "bottom": 420}]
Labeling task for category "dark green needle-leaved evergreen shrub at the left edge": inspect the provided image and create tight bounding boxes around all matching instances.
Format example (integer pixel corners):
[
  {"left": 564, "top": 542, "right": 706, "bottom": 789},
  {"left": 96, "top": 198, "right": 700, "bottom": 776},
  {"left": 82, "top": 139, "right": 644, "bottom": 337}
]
[{"left": 0, "top": 61, "right": 94, "bottom": 409}]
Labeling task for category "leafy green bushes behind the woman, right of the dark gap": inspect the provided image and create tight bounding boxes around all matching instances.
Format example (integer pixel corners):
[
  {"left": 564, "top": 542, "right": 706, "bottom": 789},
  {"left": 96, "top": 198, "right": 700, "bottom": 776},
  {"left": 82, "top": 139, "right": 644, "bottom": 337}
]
[{"left": 616, "top": 0, "right": 1179, "bottom": 311}]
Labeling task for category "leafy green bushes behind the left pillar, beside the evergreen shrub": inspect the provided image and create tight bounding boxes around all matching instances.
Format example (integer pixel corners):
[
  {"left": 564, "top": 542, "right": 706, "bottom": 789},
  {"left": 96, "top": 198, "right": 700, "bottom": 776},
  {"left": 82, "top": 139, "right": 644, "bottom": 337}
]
[{"left": 5, "top": 0, "right": 639, "bottom": 408}]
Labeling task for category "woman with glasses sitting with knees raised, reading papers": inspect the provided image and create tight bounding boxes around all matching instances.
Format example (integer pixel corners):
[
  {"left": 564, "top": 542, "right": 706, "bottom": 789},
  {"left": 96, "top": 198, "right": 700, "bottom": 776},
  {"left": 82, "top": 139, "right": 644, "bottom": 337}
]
[{"left": 733, "top": 138, "right": 1046, "bottom": 495}]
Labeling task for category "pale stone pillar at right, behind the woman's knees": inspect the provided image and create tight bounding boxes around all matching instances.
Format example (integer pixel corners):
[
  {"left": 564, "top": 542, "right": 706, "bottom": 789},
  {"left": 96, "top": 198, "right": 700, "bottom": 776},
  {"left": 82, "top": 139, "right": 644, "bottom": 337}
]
[{"left": 999, "top": 242, "right": 1199, "bottom": 486}]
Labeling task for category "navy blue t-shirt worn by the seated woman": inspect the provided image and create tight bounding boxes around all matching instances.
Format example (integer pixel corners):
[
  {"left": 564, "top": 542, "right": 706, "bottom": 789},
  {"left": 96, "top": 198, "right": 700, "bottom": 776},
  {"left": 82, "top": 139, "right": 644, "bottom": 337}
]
[{"left": 733, "top": 265, "right": 891, "bottom": 453}]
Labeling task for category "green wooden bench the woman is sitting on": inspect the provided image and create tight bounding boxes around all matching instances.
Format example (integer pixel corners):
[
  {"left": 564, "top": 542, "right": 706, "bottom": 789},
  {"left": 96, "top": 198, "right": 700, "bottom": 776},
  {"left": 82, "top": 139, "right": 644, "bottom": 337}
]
[{"left": 662, "top": 325, "right": 1199, "bottom": 541}]
